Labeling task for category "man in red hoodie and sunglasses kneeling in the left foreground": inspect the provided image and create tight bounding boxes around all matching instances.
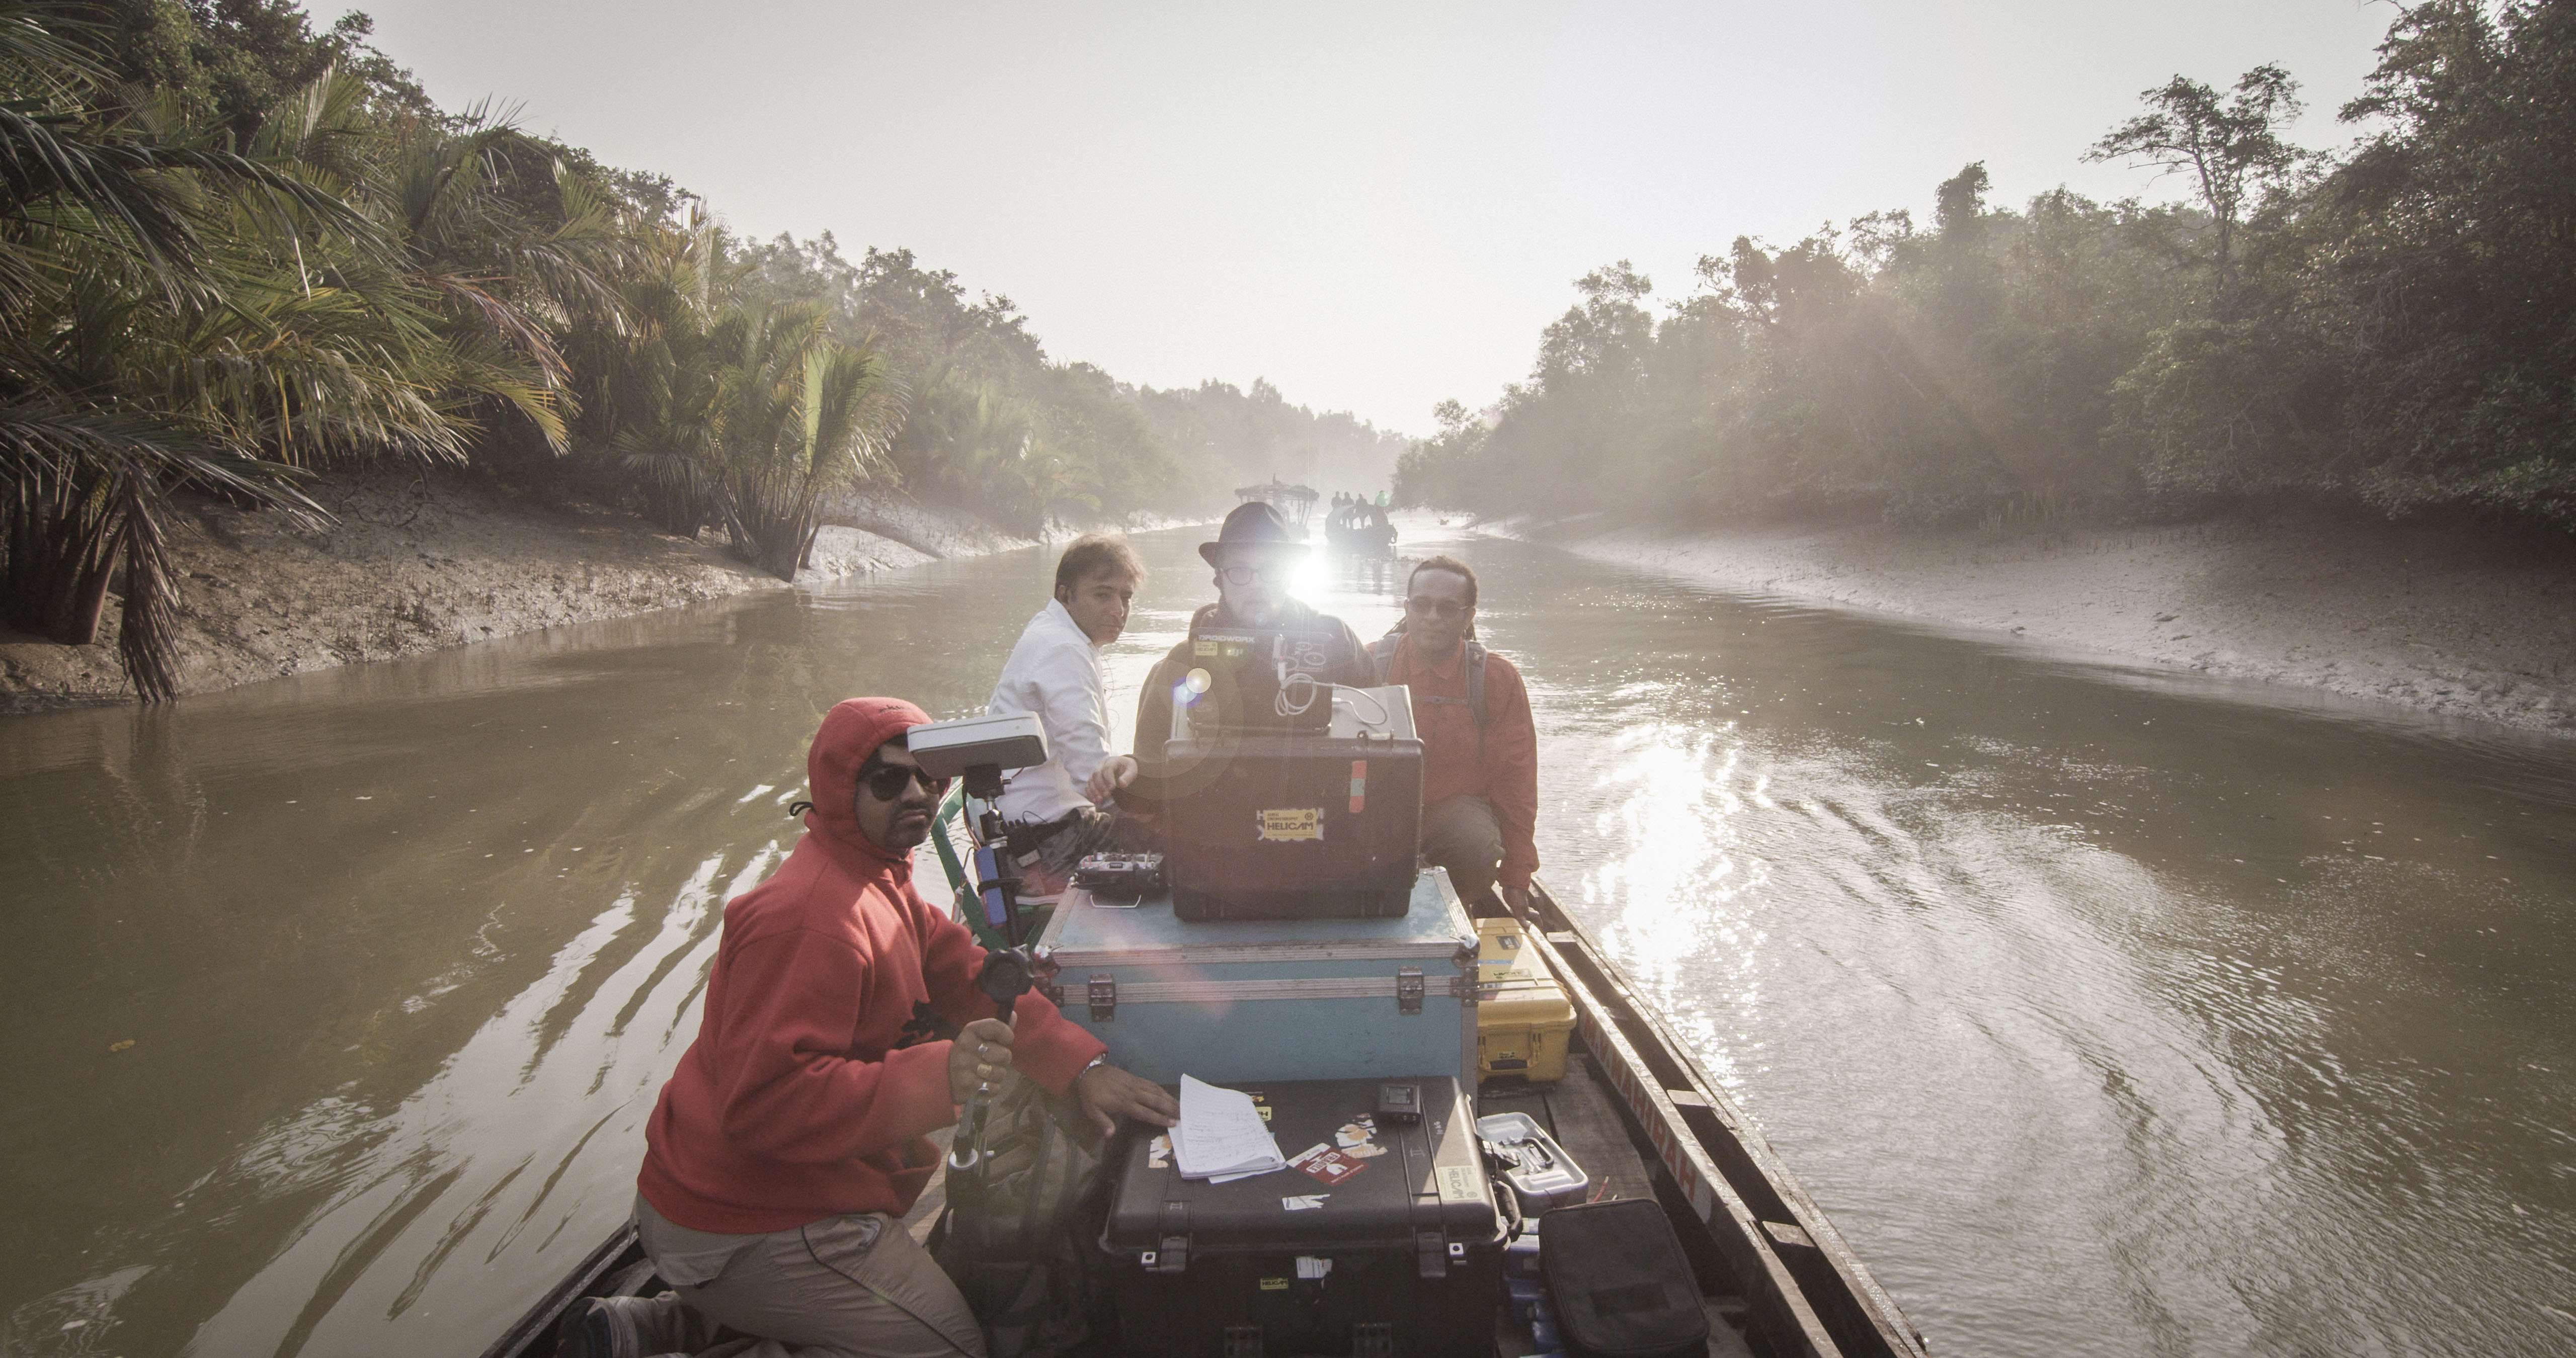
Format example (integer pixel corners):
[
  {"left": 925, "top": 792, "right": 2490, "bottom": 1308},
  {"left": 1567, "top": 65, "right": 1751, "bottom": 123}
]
[{"left": 567, "top": 698, "right": 1180, "bottom": 1358}]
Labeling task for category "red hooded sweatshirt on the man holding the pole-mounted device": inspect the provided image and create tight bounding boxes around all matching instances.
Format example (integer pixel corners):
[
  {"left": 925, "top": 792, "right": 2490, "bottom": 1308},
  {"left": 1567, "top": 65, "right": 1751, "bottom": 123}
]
[{"left": 636, "top": 698, "right": 1102, "bottom": 1234}]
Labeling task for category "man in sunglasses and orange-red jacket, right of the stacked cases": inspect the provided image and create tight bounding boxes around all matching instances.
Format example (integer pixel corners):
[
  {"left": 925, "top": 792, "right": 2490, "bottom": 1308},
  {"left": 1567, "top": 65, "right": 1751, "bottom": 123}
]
[{"left": 1368, "top": 557, "right": 1538, "bottom": 920}]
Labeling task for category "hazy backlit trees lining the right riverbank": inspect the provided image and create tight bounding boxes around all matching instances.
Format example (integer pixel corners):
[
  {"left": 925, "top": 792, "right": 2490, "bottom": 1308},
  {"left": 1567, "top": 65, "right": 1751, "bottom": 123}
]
[{"left": 1396, "top": 0, "right": 2576, "bottom": 531}]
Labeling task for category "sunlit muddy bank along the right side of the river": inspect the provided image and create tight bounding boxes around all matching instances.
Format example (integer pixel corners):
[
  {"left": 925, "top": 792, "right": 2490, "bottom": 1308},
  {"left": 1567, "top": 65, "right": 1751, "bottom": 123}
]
[{"left": 1481, "top": 516, "right": 2576, "bottom": 734}]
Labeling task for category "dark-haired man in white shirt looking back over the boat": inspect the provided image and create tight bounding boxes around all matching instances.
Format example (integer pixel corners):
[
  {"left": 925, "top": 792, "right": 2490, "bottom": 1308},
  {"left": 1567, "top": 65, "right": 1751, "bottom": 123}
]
[{"left": 987, "top": 534, "right": 1144, "bottom": 899}]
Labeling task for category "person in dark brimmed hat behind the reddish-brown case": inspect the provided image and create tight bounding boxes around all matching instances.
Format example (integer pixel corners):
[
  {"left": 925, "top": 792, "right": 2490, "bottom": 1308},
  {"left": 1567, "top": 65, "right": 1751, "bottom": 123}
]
[{"left": 1131, "top": 500, "right": 1371, "bottom": 776}]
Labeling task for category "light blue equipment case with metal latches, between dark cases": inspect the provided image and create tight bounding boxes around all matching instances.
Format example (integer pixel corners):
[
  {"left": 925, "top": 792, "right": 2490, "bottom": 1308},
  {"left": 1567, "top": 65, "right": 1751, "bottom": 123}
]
[{"left": 1038, "top": 869, "right": 1476, "bottom": 1087}]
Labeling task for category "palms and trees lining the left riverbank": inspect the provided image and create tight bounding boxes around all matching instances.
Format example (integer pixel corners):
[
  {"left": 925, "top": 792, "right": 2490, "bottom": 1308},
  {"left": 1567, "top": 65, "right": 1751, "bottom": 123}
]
[{"left": 0, "top": 0, "right": 1401, "bottom": 698}]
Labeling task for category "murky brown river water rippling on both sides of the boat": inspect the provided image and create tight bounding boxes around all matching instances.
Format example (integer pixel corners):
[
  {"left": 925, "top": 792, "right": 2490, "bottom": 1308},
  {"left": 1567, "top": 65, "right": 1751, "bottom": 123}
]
[{"left": 0, "top": 523, "right": 2576, "bottom": 1358}]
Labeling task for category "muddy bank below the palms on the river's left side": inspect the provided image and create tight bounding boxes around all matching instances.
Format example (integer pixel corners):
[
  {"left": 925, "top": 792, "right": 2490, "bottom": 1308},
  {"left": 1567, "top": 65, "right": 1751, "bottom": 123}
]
[{"left": 0, "top": 474, "right": 1028, "bottom": 711}]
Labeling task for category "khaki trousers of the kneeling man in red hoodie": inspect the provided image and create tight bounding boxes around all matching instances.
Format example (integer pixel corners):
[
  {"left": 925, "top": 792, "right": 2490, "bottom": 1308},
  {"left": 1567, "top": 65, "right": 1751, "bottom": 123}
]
[{"left": 636, "top": 1196, "right": 984, "bottom": 1358}]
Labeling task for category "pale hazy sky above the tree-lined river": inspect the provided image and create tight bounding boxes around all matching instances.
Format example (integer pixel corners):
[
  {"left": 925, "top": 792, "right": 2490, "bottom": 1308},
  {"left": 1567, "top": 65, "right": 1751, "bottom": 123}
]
[{"left": 358, "top": 0, "right": 2396, "bottom": 433}]
